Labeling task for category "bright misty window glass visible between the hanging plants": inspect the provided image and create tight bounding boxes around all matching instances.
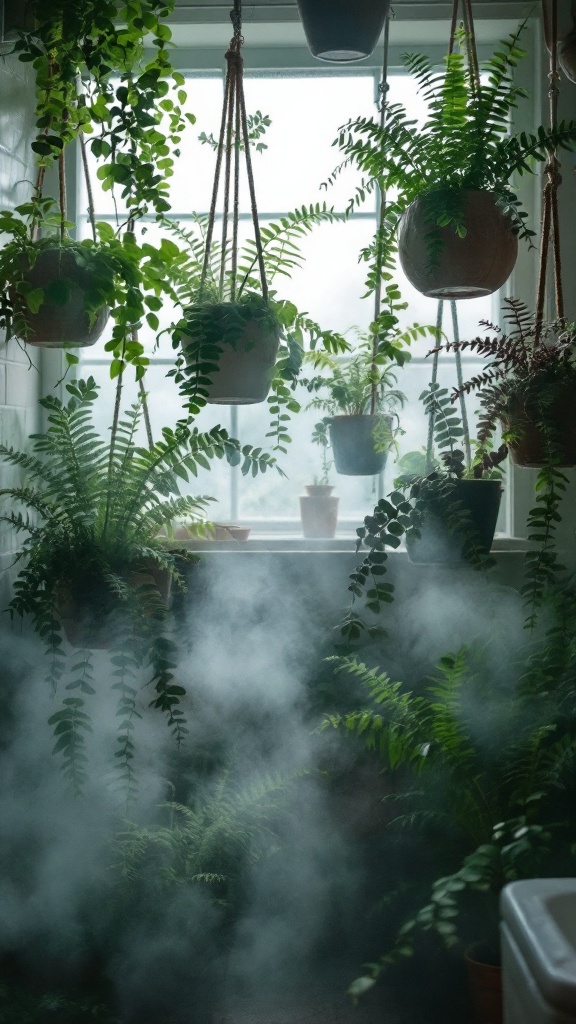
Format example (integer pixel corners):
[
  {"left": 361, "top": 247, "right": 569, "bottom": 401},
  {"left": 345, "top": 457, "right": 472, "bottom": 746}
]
[{"left": 79, "top": 24, "right": 532, "bottom": 536}]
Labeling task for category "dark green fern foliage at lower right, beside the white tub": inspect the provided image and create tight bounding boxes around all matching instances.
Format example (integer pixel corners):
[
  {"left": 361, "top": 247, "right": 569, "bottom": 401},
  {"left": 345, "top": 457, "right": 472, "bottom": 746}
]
[{"left": 324, "top": 606, "right": 576, "bottom": 1015}]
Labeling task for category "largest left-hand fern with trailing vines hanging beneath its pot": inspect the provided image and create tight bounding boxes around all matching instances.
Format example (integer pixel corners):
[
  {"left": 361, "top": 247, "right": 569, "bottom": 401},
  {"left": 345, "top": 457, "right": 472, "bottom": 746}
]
[{"left": 0, "top": 378, "right": 274, "bottom": 794}]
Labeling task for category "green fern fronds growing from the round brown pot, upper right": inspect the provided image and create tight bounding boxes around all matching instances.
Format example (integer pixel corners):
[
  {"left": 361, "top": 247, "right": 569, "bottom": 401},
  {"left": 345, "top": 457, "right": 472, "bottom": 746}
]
[{"left": 330, "top": 26, "right": 576, "bottom": 239}]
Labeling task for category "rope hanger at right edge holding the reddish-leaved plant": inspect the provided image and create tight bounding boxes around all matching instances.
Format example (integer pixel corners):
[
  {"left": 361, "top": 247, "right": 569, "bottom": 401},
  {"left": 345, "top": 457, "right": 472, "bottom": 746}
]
[{"left": 534, "top": 0, "right": 564, "bottom": 337}]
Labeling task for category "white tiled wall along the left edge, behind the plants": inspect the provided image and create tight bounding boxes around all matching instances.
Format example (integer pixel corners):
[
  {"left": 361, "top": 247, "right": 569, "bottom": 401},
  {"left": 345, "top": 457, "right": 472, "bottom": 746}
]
[{"left": 0, "top": 54, "right": 40, "bottom": 606}]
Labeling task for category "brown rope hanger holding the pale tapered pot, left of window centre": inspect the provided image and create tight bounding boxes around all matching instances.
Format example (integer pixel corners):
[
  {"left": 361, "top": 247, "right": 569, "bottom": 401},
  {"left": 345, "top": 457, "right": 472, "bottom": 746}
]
[{"left": 200, "top": 0, "right": 269, "bottom": 302}]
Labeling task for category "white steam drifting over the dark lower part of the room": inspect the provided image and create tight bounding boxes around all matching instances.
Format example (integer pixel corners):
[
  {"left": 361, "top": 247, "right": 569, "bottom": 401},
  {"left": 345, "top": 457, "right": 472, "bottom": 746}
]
[{"left": 0, "top": 553, "right": 523, "bottom": 1024}]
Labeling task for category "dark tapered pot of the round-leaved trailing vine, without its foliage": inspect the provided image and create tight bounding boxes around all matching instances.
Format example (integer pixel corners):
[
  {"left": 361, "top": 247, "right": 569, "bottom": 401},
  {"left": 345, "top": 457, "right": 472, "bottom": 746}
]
[{"left": 406, "top": 478, "right": 502, "bottom": 565}]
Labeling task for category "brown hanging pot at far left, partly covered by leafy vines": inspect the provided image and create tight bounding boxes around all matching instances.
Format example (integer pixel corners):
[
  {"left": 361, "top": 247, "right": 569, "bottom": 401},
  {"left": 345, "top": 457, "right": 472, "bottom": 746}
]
[{"left": 10, "top": 240, "right": 109, "bottom": 348}]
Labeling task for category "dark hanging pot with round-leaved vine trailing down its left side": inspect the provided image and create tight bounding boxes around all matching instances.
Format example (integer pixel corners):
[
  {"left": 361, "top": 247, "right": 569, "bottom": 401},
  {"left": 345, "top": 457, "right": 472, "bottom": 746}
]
[{"left": 340, "top": 383, "right": 507, "bottom": 641}]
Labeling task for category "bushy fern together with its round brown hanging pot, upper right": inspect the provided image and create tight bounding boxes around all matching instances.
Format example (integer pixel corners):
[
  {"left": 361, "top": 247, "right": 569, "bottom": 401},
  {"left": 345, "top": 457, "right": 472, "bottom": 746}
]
[{"left": 330, "top": 26, "right": 576, "bottom": 298}]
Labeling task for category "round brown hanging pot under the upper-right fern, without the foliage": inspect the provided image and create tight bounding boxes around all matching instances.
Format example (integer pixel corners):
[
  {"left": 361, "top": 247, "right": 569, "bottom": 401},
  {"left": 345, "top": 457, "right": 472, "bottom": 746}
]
[{"left": 398, "top": 190, "right": 518, "bottom": 299}]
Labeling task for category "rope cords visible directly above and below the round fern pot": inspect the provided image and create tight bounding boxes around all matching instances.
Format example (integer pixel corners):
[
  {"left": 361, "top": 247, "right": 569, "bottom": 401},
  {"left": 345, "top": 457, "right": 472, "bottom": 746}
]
[{"left": 426, "top": 0, "right": 480, "bottom": 473}]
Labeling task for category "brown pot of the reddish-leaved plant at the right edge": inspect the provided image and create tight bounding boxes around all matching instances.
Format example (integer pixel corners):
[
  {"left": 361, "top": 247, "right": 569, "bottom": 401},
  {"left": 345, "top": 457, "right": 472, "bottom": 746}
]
[{"left": 502, "top": 383, "right": 576, "bottom": 469}]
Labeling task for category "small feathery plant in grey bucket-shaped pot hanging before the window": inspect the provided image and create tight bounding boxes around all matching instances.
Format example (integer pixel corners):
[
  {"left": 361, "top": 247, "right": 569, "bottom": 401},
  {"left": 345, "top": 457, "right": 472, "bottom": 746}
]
[{"left": 302, "top": 284, "right": 434, "bottom": 476}]
